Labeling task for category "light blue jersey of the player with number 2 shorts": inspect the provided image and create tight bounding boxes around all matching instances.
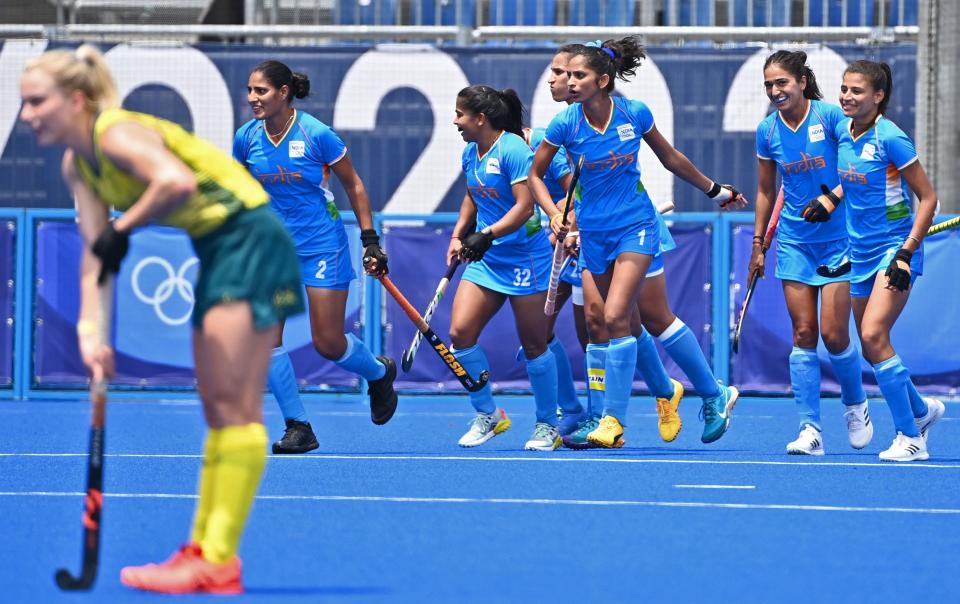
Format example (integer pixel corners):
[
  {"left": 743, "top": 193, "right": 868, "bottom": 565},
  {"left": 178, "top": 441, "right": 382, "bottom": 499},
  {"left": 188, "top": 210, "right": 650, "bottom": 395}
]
[{"left": 233, "top": 111, "right": 347, "bottom": 256}]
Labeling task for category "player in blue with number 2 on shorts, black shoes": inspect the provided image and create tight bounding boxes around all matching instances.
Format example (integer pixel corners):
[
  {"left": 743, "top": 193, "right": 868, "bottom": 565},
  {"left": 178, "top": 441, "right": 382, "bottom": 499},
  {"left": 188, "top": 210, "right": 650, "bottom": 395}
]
[{"left": 233, "top": 61, "right": 397, "bottom": 453}]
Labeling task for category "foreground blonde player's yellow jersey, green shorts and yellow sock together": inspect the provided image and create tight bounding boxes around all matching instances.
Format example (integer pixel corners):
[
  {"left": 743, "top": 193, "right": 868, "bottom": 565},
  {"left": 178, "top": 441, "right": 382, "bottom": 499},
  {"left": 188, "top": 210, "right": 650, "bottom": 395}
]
[{"left": 76, "top": 109, "right": 304, "bottom": 563}]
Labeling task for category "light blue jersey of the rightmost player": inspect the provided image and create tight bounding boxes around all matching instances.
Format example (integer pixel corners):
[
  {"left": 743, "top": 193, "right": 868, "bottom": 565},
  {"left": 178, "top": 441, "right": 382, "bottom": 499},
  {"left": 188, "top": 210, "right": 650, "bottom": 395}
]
[{"left": 837, "top": 115, "right": 923, "bottom": 282}]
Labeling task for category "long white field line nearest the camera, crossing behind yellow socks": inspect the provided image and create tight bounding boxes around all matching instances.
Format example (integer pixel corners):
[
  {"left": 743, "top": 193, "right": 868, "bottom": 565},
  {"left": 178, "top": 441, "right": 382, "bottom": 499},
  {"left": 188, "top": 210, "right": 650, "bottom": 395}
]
[{"left": 0, "top": 491, "right": 960, "bottom": 515}]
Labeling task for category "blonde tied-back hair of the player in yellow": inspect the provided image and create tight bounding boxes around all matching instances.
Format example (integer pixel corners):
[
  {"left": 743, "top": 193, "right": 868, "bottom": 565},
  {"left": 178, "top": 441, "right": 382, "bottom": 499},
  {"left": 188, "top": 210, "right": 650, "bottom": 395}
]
[{"left": 25, "top": 44, "right": 120, "bottom": 114}]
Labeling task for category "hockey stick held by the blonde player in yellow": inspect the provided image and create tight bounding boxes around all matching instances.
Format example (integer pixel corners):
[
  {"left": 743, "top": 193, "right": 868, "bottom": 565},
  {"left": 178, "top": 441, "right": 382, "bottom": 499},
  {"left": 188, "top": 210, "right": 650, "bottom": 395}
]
[{"left": 55, "top": 277, "right": 113, "bottom": 591}]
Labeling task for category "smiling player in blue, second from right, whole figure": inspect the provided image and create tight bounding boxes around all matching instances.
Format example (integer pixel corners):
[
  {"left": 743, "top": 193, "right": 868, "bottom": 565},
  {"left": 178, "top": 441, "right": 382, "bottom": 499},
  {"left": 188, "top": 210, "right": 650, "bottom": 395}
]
[{"left": 749, "top": 50, "right": 873, "bottom": 455}]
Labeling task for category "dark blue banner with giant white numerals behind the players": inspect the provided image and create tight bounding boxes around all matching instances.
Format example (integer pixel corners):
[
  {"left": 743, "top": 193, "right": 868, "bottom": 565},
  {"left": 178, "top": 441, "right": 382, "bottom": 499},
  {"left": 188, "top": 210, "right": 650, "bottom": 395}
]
[{"left": 0, "top": 41, "right": 917, "bottom": 214}]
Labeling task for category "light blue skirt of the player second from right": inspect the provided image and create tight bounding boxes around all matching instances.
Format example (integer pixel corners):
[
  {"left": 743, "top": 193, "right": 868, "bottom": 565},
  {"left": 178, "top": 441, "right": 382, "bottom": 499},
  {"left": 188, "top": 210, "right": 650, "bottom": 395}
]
[{"left": 775, "top": 238, "right": 851, "bottom": 287}]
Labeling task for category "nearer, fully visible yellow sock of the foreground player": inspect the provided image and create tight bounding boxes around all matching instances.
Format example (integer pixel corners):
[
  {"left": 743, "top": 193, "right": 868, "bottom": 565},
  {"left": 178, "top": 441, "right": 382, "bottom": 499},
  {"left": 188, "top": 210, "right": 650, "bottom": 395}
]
[{"left": 200, "top": 423, "right": 267, "bottom": 563}]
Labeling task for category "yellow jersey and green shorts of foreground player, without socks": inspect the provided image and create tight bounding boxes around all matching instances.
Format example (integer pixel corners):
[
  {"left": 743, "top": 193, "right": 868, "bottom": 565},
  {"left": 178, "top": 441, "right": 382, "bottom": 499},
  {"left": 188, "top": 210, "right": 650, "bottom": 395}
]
[{"left": 76, "top": 109, "right": 304, "bottom": 328}]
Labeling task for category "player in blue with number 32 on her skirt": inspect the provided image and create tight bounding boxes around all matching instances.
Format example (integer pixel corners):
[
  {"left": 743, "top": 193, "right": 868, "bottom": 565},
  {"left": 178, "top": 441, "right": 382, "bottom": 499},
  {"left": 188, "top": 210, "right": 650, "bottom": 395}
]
[{"left": 447, "top": 86, "right": 583, "bottom": 451}]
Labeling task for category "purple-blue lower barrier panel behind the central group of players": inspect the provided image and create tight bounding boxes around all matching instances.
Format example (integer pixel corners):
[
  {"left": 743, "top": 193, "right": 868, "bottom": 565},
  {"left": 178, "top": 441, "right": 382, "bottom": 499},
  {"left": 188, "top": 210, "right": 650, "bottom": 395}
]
[{"left": 383, "top": 215, "right": 713, "bottom": 392}]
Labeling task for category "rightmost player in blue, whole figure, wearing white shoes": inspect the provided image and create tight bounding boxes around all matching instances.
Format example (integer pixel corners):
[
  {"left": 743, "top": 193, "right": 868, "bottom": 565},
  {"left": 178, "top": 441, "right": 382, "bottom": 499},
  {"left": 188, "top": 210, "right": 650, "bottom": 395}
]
[{"left": 836, "top": 61, "right": 944, "bottom": 461}]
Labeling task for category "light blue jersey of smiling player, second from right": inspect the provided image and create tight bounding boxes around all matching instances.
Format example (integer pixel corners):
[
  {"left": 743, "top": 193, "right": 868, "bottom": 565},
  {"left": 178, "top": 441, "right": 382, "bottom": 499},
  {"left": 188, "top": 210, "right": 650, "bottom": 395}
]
[{"left": 757, "top": 100, "right": 847, "bottom": 243}]
